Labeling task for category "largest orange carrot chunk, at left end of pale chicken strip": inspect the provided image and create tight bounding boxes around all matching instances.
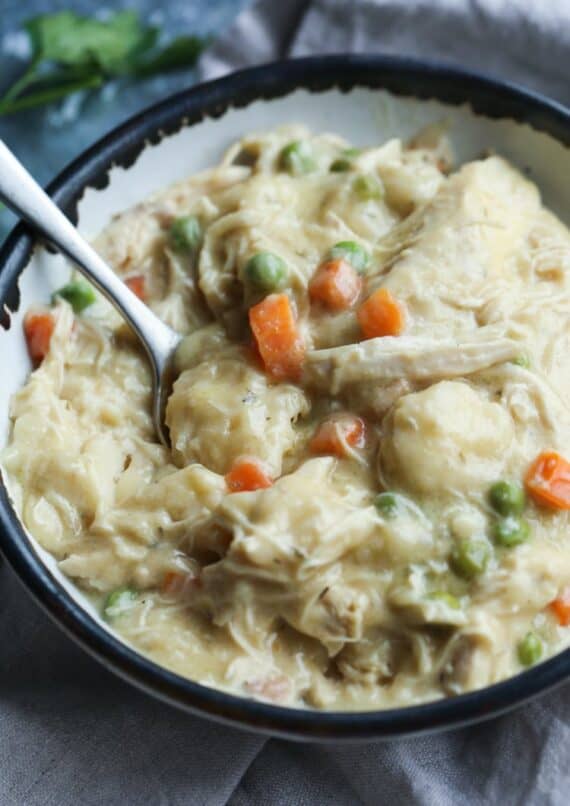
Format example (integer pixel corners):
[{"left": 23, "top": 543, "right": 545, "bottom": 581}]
[{"left": 249, "top": 294, "right": 305, "bottom": 380}]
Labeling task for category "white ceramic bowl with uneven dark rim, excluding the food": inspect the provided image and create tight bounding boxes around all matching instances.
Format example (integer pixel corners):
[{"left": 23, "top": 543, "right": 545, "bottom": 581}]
[{"left": 0, "top": 56, "right": 570, "bottom": 741}]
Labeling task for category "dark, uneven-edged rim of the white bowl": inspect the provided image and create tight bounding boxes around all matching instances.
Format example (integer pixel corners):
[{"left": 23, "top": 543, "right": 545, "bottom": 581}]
[{"left": 0, "top": 54, "right": 570, "bottom": 741}]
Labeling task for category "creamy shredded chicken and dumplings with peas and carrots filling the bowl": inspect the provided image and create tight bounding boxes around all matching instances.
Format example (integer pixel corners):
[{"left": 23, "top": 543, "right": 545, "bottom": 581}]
[{"left": 3, "top": 127, "right": 570, "bottom": 710}]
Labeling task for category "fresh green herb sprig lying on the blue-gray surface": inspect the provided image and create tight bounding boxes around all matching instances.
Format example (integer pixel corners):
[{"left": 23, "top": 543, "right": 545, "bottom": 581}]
[{"left": 0, "top": 11, "right": 208, "bottom": 115}]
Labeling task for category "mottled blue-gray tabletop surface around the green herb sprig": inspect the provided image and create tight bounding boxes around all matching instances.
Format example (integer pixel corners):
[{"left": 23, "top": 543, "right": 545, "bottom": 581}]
[{"left": 0, "top": 0, "right": 248, "bottom": 242}]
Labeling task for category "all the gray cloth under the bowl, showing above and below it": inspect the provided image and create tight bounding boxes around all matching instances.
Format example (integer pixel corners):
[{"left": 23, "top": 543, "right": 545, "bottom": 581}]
[{"left": 0, "top": 0, "right": 570, "bottom": 806}]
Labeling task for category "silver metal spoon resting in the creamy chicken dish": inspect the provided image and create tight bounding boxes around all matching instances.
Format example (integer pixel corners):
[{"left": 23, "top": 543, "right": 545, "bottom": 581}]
[{"left": 0, "top": 140, "right": 180, "bottom": 447}]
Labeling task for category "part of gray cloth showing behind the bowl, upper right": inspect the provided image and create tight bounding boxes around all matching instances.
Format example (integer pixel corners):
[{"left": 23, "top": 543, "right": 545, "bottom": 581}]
[{"left": 201, "top": 0, "right": 570, "bottom": 104}]
